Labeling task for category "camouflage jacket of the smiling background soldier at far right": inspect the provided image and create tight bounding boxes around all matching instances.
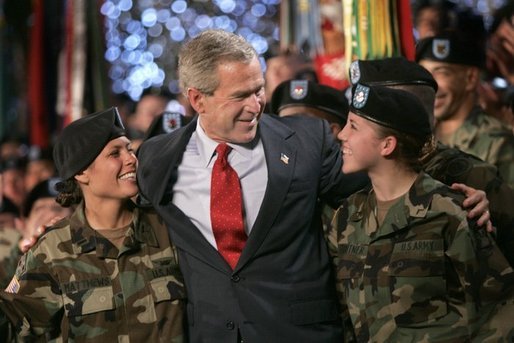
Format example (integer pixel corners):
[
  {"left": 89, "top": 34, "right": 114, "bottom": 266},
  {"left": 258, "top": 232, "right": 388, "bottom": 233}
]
[{"left": 434, "top": 106, "right": 514, "bottom": 187}]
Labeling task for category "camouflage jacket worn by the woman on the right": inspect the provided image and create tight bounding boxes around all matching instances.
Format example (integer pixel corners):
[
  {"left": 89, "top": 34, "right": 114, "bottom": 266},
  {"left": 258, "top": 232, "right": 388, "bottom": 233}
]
[{"left": 329, "top": 173, "right": 514, "bottom": 342}]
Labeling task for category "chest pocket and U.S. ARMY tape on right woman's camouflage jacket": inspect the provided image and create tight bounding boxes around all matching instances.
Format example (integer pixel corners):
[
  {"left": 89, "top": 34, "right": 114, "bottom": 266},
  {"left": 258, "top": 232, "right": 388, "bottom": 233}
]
[{"left": 389, "top": 240, "right": 448, "bottom": 327}]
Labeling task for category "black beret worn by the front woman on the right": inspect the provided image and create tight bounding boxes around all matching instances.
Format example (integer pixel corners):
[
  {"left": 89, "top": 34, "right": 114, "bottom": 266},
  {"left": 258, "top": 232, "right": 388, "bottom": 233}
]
[{"left": 350, "top": 83, "right": 432, "bottom": 136}]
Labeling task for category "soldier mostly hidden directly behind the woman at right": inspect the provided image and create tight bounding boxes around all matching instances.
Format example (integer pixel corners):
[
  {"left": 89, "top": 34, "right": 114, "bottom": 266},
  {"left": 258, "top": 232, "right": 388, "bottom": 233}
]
[{"left": 350, "top": 57, "right": 514, "bottom": 266}]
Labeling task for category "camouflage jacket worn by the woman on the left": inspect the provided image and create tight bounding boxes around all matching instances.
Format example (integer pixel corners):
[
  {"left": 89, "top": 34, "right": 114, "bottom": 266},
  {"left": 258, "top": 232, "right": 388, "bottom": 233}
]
[{"left": 0, "top": 206, "right": 185, "bottom": 343}]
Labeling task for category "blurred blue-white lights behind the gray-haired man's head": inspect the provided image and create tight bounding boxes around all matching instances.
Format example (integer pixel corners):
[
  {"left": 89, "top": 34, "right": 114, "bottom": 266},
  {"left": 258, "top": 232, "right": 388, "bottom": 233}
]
[{"left": 101, "top": 0, "right": 280, "bottom": 100}]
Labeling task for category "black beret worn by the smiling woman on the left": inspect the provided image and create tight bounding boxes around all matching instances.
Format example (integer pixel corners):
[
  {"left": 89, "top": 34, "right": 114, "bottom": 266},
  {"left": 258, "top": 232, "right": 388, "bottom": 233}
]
[{"left": 53, "top": 107, "right": 125, "bottom": 180}]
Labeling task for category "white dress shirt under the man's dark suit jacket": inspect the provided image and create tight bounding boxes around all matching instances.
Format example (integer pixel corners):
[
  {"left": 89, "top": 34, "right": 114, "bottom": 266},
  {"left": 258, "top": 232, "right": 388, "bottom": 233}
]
[{"left": 172, "top": 118, "right": 268, "bottom": 249}]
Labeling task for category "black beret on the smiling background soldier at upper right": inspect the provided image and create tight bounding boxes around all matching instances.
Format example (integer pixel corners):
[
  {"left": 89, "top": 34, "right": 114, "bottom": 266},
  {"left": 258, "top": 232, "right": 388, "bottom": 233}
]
[{"left": 416, "top": 31, "right": 485, "bottom": 68}]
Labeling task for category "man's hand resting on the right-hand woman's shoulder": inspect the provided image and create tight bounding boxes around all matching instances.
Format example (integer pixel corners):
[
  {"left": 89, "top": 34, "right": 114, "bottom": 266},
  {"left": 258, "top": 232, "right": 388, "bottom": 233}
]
[{"left": 451, "top": 183, "right": 494, "bottom": 232}]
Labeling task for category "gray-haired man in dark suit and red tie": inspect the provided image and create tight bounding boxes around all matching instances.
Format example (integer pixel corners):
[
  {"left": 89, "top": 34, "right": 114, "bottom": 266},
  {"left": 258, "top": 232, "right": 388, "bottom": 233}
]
[{"left": 138, "top": 30, "right": 366, "bottom": 343}]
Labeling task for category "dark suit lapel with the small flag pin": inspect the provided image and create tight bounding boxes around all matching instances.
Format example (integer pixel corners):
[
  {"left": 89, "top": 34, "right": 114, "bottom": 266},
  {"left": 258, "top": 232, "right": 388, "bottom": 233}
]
[{"left": 234, "top": 114, "right": 296, "bottom": 271}]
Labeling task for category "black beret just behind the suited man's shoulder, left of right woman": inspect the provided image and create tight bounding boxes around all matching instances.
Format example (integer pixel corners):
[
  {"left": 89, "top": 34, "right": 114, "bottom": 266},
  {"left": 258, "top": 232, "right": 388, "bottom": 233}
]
[{"left": 270, "top": 80, "right": 348, "bottom": 122}]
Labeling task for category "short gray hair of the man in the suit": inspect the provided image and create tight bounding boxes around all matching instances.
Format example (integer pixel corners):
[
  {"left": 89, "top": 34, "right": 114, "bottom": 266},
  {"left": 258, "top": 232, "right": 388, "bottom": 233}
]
[{"left": 178, "top": 30, "right": 257, "bottom": 95}]
